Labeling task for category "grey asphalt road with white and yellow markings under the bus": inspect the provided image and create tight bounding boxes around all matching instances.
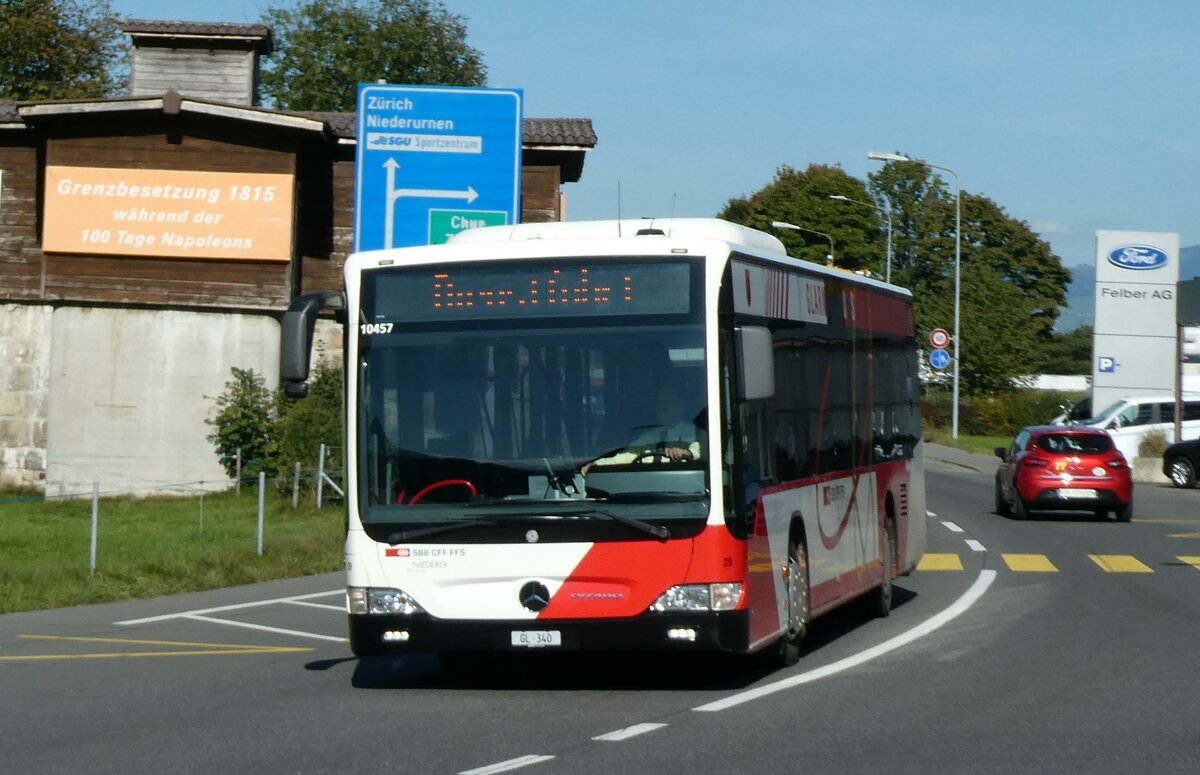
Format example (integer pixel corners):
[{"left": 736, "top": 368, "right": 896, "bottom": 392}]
[{"left": 0, "top": 447, "right": 1200, "bottom": 775}]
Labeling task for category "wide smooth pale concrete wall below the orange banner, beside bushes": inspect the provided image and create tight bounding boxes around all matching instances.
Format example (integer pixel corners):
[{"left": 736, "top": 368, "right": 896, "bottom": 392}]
[{"left": 46, "top": 307, "right": 280, "bottom": 497}]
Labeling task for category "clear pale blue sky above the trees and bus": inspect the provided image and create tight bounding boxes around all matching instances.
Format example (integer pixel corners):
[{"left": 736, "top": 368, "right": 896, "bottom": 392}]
[{"left": 110, "top": 0, "right": 1200, "bottom": 273}]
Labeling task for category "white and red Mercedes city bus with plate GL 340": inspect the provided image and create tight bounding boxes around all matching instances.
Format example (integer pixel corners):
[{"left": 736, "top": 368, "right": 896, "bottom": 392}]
[{"left": 281, "top": 218, "right": 925, "bottom": 666}]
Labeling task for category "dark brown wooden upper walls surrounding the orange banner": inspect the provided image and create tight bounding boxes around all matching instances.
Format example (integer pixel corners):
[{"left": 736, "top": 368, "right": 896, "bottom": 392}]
[{"left": 0, "top": 98, "right": 595, "bottom": 313}]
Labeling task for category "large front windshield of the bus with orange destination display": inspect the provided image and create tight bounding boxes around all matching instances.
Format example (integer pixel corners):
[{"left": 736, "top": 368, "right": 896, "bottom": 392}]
[{"left": 355, "top": 258, "right": 709, "bottom": 540}]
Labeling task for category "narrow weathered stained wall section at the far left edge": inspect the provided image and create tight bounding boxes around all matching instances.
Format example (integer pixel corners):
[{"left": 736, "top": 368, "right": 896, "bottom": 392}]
[{"left": 0, "top": 304, "right": 52, "bottom": 487}]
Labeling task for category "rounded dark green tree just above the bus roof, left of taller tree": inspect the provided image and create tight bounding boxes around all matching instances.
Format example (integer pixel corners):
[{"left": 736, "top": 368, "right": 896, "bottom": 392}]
[{"left": 718, "top": 164, "right": 886, "bottom": 276}]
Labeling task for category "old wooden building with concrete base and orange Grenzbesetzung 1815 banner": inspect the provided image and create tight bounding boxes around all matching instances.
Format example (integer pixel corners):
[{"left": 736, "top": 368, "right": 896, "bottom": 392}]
[{"left": 0, "top": 22, "right": 596, "bottom": 494}]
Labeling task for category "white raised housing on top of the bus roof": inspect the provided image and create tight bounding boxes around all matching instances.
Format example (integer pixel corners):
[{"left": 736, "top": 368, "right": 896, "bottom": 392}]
[{"left": 449, "top": 218, "right": 787, "bottom": 256}]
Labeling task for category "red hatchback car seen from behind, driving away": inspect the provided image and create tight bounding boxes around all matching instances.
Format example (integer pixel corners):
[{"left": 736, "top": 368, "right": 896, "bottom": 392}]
[{"left": 996, "top": 425, "right": 1133, "bottom": 522}]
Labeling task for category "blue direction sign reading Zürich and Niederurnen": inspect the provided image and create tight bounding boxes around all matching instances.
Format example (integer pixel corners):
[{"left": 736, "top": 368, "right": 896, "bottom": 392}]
[{"left": 354, "top": 84, "right": 524, "bottom": 251}]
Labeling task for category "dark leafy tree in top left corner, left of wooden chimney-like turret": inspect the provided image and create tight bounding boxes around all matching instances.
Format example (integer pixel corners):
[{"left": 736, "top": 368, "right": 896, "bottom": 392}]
[{"left": 0, "top": 0, "right": 125, "bottom": 101}]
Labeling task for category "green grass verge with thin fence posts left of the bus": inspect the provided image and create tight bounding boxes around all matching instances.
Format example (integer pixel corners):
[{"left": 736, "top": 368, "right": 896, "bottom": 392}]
[{"left": 0, "top": 488, "right": 346, "bottom": 613}]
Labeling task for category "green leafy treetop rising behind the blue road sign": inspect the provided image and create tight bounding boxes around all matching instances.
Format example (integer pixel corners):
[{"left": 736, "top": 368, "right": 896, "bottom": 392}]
[{"left": 262, "top": 0, "right": 487, "bottom": 110}]
